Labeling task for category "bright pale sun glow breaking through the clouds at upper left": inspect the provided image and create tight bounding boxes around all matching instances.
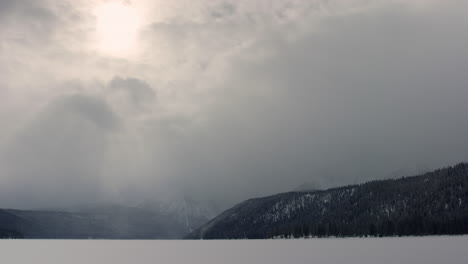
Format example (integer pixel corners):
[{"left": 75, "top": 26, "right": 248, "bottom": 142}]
[{"left": 95, "top": 2, "right": 140, "bottom": 56}]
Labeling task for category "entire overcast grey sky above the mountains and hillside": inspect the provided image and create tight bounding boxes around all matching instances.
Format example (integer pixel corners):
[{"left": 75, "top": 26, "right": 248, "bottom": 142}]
[{"left": 0, "top": 0, "right": 468, "bottom": 208}]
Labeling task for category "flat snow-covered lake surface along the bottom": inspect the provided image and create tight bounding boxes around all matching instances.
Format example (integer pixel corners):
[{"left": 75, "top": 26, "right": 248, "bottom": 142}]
[{"left": 0, "top": 236, "right": 468, "bottom": 264}]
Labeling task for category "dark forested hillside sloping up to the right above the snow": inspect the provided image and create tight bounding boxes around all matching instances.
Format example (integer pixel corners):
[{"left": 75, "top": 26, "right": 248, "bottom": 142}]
[{"left": 188, "top": 163, "right": 468, "bottom": 239}]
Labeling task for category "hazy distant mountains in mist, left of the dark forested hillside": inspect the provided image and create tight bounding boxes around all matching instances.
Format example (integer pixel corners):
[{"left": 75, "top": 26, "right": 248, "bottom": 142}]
[{"left": 0, "top": 199, "right": 219, "bottom": 239}]
